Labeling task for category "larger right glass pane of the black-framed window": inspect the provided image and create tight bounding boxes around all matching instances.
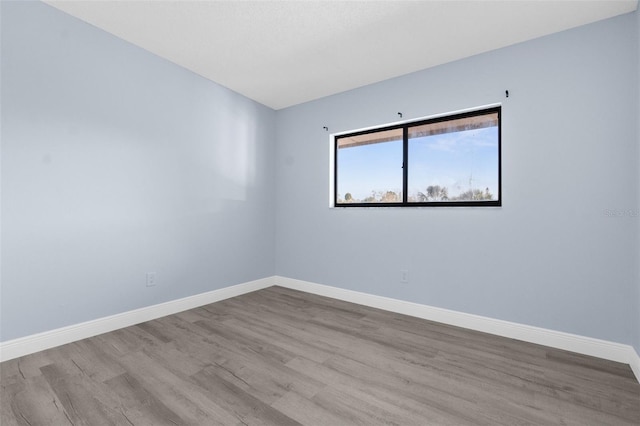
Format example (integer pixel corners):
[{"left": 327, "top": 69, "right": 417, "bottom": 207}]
[{"left": 408, "top": 112, "right": 500, "bottom": 203}]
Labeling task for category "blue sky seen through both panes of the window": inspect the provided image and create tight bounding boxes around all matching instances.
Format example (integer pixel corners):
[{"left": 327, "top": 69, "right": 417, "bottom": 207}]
[{"left": 337, "top": 126, "right": 499, "bottom": 201}]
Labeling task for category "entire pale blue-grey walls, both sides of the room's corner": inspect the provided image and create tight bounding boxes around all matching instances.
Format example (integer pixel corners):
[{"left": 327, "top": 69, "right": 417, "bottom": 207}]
[{"left": 0, "top": 2, "right": 640, "bottom": 352}]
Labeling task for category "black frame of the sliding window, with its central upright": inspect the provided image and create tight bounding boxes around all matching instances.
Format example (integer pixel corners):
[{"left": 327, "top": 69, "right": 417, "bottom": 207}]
[{"left": 333, "top": 105, "right": 502, "bottom": 208}]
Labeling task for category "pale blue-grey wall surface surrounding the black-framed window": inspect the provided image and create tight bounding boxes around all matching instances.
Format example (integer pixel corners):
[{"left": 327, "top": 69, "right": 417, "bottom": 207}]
[{"left": 276, "top": 14, "right": 639, "bottom": 344}]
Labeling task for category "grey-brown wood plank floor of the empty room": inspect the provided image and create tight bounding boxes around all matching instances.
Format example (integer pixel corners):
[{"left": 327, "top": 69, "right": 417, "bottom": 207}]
[{"left": 0, "top": 287, "right": 640, "bottom": 426}]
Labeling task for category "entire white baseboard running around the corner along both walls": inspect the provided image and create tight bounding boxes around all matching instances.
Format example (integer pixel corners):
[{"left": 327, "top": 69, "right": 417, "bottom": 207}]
[{"left": 0, "top": 276, "right": 640, "bottom": 388}]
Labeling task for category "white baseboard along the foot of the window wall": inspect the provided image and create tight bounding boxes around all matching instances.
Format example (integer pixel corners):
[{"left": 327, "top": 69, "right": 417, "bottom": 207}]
[{"left": 275, "top": 276, "right": 640, "bottom": 382}]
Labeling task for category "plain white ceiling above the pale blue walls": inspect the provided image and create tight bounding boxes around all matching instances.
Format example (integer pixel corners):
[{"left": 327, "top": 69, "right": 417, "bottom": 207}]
[{"left": 46, "top": 0, "right": 638, "bottom": 109}]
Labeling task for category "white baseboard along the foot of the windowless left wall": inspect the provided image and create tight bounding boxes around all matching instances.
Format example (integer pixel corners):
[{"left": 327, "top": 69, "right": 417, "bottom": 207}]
[{"left": 0, "top": 277, "right": 275, "bottom": 362}]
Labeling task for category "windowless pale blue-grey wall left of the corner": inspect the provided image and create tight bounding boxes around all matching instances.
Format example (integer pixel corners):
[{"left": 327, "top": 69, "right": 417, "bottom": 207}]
[{"left": 0, "top": 2, "right": 275, "bottom": 341}]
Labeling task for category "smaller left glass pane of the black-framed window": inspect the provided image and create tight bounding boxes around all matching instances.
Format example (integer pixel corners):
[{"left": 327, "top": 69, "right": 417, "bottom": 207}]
[{"left": 336, "top": 129, "right": 403, "bottom": 204}]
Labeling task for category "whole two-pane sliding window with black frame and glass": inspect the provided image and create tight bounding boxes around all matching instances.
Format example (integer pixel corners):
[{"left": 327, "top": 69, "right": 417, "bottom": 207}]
[{"left": 334, "top": 107, "right": 501, "bottom": 207}]
